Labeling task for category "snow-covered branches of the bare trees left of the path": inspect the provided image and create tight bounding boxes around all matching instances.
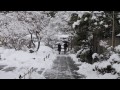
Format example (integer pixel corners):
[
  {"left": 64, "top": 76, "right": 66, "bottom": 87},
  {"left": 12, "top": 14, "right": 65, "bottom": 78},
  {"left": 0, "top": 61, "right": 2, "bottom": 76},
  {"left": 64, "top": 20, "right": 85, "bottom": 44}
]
[{"left": 0, "top": 11, "right": 50, "bottom": 50}]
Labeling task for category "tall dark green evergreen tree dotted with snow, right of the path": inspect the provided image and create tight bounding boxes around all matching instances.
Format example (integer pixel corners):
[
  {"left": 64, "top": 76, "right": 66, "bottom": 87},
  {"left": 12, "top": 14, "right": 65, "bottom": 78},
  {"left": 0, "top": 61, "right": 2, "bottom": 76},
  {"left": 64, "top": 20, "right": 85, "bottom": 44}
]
[{"left": 74, "top": 11, "right": 120, "bottom": 63}]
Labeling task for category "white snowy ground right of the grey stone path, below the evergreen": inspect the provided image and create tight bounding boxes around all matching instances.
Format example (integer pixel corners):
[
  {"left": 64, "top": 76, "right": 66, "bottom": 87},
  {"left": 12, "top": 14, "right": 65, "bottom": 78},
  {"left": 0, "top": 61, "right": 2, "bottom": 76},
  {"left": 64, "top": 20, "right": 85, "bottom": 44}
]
[{"left": 70, "top": 54, "right": 120, "bottom": 79}]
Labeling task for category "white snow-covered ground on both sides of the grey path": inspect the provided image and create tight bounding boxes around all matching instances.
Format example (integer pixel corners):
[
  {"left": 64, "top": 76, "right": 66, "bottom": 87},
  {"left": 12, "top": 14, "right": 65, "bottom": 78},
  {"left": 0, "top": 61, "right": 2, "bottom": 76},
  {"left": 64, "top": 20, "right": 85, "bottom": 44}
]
[{"left": 0, "top": 41, "right": 120, "bottom": 79}]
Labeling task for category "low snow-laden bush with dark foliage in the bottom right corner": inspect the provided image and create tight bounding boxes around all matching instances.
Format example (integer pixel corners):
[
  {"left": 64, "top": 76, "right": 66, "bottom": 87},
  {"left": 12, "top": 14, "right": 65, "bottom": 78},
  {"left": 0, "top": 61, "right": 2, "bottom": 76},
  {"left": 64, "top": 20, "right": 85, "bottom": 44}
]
[{"left": 93, "top": 54, "right": 120, "bottom": 76}]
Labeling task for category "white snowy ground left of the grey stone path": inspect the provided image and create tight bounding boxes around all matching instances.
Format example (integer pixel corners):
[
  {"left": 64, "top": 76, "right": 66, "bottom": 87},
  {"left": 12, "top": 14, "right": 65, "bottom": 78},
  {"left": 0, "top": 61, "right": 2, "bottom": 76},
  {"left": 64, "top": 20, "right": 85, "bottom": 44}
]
[{"left": 0, "top": 44, "right": 56, "bottom": 79}]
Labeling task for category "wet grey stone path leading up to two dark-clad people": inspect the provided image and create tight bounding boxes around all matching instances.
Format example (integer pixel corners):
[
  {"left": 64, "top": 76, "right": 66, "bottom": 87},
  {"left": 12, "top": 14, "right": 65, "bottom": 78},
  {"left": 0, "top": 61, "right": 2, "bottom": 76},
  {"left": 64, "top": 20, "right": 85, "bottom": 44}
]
[{"left": 44, "top": 55, "right": 84, "bottom": 79}]
